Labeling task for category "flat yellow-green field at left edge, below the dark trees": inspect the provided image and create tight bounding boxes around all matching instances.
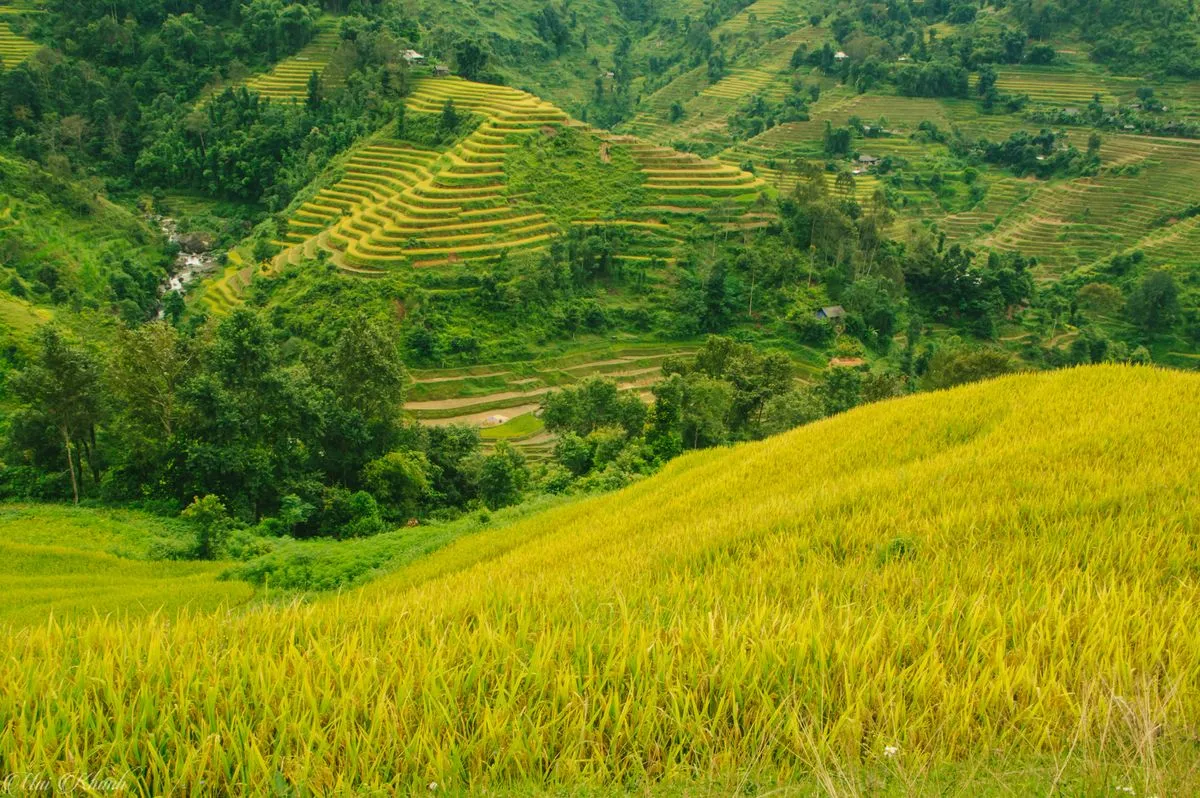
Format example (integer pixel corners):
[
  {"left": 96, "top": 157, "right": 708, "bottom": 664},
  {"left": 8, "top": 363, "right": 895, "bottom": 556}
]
[{"left": 0, "top": 505, "right": 252, "bottom": 628}]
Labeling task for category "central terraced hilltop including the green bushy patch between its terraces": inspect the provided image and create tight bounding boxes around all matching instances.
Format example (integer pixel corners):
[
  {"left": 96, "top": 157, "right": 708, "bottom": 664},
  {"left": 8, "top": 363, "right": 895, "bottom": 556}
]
[{"left": 264, "top": 77, "right": 769, "bottom": 276}]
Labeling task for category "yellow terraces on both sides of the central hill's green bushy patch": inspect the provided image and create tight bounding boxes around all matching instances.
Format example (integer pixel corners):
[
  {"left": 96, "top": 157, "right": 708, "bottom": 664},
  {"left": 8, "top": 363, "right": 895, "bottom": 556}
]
[{"left": 276, "top": 78, "right": 762, "bottom": 276}]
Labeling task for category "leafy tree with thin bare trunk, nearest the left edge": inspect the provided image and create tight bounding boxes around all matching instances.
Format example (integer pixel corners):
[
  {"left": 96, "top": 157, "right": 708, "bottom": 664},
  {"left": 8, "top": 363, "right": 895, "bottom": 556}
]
[{"left": 10, "top": 325, "right": 103, "bottom": 504}]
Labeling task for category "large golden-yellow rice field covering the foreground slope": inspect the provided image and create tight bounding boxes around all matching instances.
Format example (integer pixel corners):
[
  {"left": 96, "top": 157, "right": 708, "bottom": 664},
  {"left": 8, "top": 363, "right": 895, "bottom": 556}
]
[{"left": 0, "top": 367, "right": 1200, "bottom": 796}]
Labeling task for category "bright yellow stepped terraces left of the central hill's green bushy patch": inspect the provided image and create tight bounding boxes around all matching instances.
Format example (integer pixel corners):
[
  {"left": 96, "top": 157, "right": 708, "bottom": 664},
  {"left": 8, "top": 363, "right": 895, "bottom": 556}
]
[{"left": 274, "top": 78, "right": 569, "bottom": 275}]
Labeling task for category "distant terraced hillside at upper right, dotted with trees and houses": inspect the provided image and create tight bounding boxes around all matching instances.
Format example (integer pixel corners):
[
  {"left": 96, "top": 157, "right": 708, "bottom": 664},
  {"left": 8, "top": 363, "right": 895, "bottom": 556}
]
[{"left": 620, "top": 0, "right": 1200, "bottom": 278}]
